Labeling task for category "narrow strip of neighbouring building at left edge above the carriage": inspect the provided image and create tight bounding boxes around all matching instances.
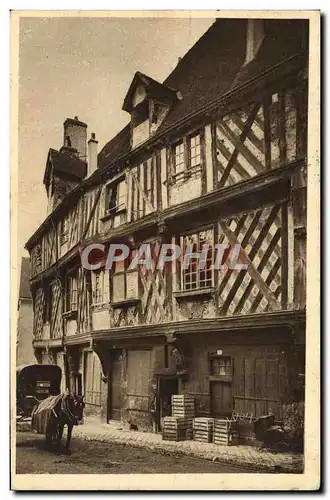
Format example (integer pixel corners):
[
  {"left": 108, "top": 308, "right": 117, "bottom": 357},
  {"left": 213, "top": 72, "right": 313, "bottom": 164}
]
[{"left": 16, "top": 257, "right": 36, "bottom": 366}]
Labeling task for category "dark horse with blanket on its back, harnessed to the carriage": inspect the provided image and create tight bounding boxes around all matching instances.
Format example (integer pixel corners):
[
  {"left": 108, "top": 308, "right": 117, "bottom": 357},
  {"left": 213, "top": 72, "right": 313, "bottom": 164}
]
[{"left": 31, "top": 394, "right": 85, "bottom": 455}]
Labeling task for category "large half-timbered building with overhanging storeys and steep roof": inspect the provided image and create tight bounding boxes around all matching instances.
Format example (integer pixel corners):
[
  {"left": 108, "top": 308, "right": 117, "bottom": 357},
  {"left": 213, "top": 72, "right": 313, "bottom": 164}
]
[{"left": 26, "top": 19, "right": 308, "bottom": 430}]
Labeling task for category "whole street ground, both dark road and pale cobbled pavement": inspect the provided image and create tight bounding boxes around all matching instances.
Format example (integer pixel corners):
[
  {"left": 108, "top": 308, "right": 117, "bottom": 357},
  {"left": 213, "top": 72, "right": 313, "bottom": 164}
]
[{"left": 17, "top": 419, "right": 303, "bottom": 474}]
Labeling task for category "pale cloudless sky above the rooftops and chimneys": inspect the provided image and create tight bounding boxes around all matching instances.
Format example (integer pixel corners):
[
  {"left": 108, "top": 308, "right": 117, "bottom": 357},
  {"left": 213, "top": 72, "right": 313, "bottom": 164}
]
[{"left": 18, "top": 17, "right": 213, "bottom": 276}]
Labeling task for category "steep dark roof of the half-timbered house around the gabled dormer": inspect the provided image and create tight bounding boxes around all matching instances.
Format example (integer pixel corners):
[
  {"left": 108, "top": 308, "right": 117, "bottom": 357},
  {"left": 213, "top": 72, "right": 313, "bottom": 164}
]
[{"left": 98, "top": 19, "right": 308, "bottom": 171}]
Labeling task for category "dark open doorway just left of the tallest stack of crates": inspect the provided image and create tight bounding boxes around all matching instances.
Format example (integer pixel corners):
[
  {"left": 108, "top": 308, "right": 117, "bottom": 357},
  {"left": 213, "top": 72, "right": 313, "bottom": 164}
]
[{"left": 156, "top": 376, "right": 179, "bottom": 432}]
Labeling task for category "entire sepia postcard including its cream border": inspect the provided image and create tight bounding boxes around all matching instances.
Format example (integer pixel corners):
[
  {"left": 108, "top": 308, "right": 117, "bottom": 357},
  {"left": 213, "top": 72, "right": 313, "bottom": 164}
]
[{"left": 11, "top": 11, "right": 320, "bottom": 490}]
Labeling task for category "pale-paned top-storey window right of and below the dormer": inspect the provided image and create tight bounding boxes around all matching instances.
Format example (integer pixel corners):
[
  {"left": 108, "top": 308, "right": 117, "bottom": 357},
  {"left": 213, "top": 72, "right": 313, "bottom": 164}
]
[{"left": 172, "top": 134, "right": 201, "bottom": 176}]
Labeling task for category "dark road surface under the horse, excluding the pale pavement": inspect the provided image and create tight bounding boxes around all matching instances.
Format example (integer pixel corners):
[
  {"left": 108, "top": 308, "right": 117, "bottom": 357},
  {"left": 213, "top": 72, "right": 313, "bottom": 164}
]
[{"left": 16, "top": 432, "right": 252, "bottom": 474}]
